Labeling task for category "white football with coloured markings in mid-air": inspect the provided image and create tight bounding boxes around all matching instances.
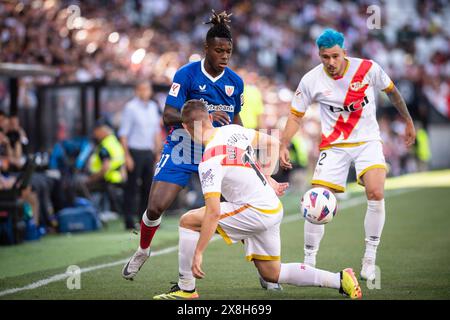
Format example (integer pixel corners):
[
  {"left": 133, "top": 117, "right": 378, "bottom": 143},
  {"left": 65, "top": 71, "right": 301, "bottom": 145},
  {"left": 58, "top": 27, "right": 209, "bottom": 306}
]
[{"left": 301, "top": 187, "right": 337, "bottom": 224}]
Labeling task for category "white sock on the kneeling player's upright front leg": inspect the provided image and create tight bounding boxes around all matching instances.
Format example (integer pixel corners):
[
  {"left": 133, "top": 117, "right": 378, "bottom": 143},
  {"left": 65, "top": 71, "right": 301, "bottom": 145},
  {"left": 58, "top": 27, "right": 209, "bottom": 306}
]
[{"left": 178, "top": 227, "right": 200, "bottom": 291}]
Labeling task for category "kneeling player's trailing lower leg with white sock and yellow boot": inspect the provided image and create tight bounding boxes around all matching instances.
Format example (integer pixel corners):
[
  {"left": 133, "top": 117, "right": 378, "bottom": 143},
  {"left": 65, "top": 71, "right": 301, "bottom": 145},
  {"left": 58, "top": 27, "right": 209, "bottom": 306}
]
[{"left": 254, "top": 260, "right": 362, "bottom": 299}]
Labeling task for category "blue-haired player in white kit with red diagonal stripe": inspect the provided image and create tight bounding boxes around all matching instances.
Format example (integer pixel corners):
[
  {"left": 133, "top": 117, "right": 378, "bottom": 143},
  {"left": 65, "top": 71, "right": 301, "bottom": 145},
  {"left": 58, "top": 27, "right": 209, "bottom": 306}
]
[{"left": 280, "top": 29, "right": 416, "bottom": 280}]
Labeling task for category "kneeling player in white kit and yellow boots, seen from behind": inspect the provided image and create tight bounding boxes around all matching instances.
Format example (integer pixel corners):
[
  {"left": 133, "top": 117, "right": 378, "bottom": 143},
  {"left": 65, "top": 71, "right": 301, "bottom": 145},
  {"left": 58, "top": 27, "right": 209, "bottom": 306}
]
[{"left": 154, "top": 100, "right": 362, "bottom": 300}]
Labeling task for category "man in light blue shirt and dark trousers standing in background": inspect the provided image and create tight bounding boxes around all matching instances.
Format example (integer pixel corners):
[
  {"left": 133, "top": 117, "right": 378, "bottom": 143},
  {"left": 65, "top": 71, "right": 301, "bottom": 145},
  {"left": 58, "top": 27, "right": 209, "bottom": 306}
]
[{"left": 119, "top": 81, "right": 161, "bottom": 229}]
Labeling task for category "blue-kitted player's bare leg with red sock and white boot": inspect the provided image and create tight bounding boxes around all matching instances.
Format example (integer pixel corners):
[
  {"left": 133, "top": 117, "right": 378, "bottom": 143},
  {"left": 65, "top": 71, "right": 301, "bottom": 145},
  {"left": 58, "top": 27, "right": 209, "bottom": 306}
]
[{"left": 122, "top": 181, "right": 182, "bottom": 280}]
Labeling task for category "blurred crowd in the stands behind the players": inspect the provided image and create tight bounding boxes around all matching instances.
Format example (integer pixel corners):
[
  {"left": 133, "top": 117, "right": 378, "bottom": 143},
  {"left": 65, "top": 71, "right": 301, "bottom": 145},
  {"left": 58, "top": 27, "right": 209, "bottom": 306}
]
[{"left": 0, "top": 0, "right": 450, "bottom": 235}]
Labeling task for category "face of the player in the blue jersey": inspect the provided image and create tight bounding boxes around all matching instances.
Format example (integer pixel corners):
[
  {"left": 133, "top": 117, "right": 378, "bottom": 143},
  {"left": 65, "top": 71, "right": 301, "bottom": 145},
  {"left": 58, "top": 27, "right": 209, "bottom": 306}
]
[{"left": 205, "top": 38, "right": 233, "bottom": 76}]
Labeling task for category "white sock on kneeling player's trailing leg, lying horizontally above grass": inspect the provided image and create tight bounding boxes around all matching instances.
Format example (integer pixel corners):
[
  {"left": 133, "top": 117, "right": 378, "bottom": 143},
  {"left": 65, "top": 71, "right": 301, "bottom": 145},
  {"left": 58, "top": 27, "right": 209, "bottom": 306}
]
[{"left": 278, "top": 263, "right": 341, "bottom": 289}]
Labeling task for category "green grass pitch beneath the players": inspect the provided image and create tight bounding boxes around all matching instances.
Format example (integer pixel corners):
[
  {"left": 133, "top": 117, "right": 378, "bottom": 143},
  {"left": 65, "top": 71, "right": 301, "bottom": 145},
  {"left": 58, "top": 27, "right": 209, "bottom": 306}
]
[{"left": 0, "top": 170, "right": 450, "bottom": 300}]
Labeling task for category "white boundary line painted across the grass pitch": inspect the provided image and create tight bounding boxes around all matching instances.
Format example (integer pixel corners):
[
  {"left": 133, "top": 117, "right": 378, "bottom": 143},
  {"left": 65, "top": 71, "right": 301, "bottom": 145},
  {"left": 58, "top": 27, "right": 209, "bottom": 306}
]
[{"left": 0, "top": 190, "right": 410, "bottom": 297}]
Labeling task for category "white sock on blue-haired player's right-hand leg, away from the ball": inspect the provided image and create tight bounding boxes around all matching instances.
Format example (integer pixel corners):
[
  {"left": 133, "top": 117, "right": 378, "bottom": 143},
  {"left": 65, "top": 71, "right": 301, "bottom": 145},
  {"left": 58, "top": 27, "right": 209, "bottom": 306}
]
[{"left": 364, "top": 199, "right": 385, "bottom": 262}]
